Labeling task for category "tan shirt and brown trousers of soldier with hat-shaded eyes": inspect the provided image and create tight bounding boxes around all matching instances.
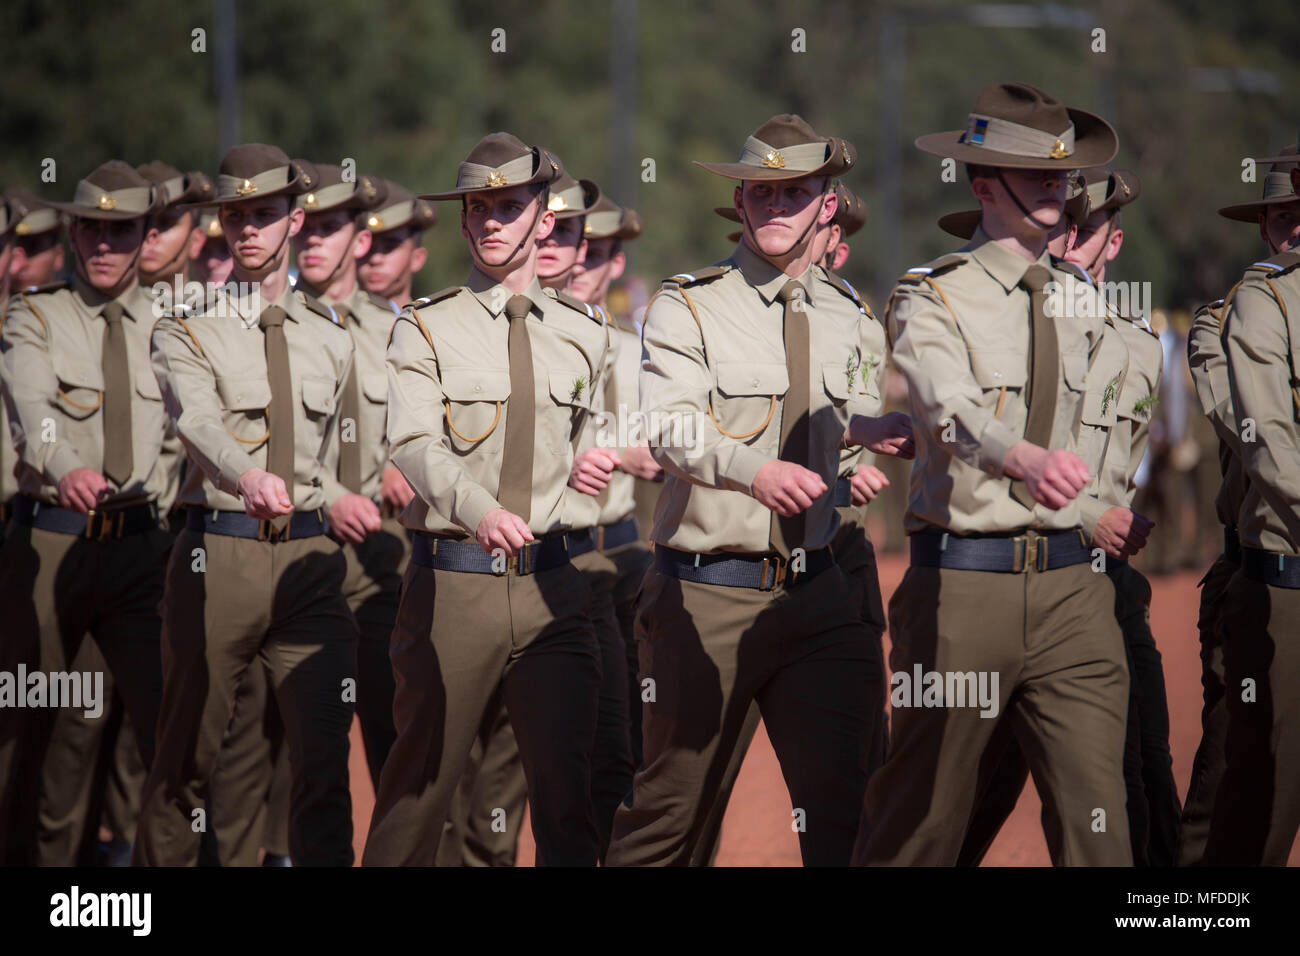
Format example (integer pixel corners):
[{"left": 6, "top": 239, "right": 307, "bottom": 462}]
[{"left": 608, "top": 245, "right": 880, "bottom": 865}]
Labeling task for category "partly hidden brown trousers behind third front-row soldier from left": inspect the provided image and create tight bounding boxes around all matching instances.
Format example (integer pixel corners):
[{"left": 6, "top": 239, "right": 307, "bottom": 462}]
[{"left": 438, "top": 538, "right": 633, "bottom": 866}]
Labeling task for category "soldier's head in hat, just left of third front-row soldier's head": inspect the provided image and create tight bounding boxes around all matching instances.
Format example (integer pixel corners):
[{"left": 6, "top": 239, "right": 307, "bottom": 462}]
[{"left": 358, "top": 178, "right": 438, "bottom": 308}]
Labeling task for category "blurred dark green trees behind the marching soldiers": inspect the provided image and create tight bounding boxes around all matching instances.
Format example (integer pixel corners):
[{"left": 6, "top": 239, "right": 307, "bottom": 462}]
[{"left": 0, "top": 0, "right": 1300, "bottom": 307}]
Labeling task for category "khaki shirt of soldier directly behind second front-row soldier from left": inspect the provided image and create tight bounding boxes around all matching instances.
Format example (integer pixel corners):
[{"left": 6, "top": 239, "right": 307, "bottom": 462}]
[{"left": 299, "top": 281, "right": 398, "bottom": 502}]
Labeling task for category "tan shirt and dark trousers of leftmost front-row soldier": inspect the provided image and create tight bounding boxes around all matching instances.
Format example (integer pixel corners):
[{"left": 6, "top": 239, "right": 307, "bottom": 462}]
[{"left": 0, "top": 282, "right": 170, "bottom": 862}]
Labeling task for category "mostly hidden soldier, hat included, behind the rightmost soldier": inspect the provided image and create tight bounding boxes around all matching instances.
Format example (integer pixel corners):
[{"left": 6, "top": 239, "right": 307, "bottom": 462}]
[{"left": 1178, "top": 146, "right": 1300, "bottom": 866}]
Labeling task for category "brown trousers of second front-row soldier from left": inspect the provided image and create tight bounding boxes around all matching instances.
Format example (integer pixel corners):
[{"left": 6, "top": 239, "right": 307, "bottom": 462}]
[{"left": 135, "top": 531, "right": 356, "bottom": 866}]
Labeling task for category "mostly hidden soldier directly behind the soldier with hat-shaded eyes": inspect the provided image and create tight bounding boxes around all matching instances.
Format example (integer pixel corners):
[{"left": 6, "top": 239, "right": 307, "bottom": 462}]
[{"left": 693, "top": 179, "right": 907, "bottom": 866}]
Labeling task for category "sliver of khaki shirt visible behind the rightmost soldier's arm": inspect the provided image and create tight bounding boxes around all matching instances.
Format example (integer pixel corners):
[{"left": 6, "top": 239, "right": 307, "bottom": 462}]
[{"left": 1187, "top": 299, "right": 1247, "bottom": 528}]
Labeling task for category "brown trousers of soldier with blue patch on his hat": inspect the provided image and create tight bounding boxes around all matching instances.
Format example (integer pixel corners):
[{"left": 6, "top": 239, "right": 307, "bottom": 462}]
[{"left": 854, "top": 563, "right": 1132, "bottom": 866}]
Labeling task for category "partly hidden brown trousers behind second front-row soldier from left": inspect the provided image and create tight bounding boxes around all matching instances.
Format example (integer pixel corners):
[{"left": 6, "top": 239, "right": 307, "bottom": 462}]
[{"left": 209, "top": 518, "right": 411, "bottom": 866}]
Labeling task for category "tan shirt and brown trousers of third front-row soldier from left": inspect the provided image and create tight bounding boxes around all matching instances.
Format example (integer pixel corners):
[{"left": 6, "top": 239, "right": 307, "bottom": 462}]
[{"left": 365, "top": 271, "right": 606, "bottom": 865}]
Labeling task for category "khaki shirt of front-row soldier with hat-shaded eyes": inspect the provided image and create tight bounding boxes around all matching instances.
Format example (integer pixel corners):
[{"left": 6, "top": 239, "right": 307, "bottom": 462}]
[{"left": 640, "top": 243, "right": 879, "bottom": 554}]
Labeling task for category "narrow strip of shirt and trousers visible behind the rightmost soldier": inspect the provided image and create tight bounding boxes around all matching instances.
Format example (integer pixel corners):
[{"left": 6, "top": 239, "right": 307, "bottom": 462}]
[{"left": 1177, "top": 299, "right": 1245, "bottom": 866}]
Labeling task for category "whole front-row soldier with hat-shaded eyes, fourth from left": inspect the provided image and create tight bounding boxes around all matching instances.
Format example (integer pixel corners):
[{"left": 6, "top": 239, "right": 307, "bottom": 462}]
[{"left": 608, "top": 114, "right": 911, "bottom": 865}]
